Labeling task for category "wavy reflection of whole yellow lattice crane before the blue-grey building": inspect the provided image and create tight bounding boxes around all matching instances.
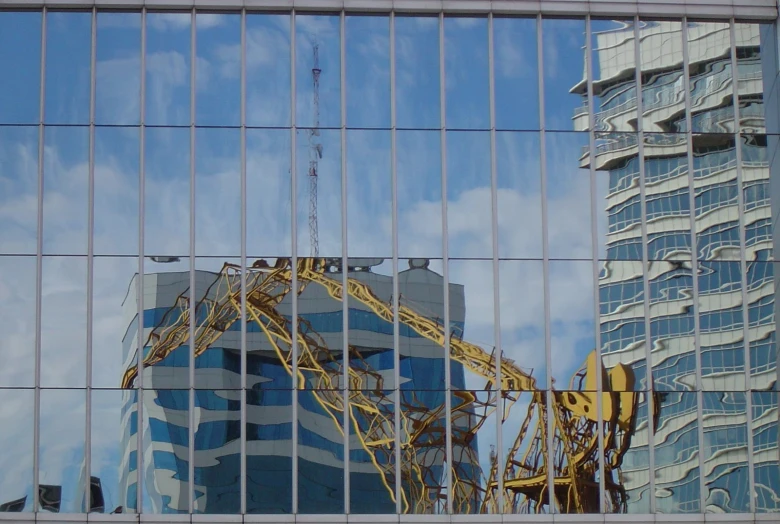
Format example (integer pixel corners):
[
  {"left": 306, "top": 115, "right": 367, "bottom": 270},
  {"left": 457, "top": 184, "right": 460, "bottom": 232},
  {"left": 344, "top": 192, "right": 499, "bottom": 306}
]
[{"left": 122, "top": 259, "right": 636, "bottom": 513}]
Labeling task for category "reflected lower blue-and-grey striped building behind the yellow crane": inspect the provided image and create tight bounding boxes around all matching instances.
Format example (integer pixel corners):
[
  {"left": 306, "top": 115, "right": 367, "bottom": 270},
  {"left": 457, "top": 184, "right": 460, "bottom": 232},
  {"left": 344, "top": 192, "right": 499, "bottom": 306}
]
[{"left": 116, "top": 260, "right": 470, "bottom": 513}]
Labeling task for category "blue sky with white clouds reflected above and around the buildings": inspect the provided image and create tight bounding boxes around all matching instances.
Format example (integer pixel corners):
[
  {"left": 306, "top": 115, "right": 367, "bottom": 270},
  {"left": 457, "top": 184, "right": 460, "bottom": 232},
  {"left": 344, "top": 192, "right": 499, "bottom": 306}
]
[{"left": 0, "top": 13, "right": 606, "bottom": 510}]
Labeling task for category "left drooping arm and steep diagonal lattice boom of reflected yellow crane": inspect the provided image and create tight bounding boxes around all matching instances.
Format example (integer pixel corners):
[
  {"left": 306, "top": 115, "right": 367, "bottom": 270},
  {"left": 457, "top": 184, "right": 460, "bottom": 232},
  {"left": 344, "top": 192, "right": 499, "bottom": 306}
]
[{"left": 123, "top": 264, "right": 448, "bottom": 511}]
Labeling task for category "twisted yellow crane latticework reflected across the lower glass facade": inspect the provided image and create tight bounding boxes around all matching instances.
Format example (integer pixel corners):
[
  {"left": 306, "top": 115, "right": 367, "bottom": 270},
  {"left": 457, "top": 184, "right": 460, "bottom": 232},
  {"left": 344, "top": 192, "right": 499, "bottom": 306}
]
[{"left": 123, "top": 259, "right": 636, "bottom": 512}]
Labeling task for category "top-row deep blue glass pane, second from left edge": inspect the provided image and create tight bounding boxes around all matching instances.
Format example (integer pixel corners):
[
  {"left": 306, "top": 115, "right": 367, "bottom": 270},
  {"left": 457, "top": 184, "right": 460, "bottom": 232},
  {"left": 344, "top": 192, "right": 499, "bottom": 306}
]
[{"left": 44, "top": 11, "right": 92, "bottom": 124}]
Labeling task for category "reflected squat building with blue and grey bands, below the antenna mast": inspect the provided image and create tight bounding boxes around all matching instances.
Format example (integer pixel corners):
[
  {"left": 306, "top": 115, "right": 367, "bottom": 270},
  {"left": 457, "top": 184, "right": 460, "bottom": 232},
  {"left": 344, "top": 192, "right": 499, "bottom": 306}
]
[{"left": 121, "top": 259, "right": 477, "bottom": 513}]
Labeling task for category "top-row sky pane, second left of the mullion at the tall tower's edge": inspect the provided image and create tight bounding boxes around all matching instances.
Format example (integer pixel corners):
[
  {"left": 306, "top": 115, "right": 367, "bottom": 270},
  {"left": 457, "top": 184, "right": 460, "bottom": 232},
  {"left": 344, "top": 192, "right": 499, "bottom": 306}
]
[{"left": 493, "top": 18, "right": 539, "bottom": 130}]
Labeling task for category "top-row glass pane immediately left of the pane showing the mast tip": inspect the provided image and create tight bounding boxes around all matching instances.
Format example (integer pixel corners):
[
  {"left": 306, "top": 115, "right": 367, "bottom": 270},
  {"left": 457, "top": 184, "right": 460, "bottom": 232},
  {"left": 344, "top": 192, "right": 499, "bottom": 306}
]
[{"left": 246, "top": 14, "right": 290, "bottom": 127}]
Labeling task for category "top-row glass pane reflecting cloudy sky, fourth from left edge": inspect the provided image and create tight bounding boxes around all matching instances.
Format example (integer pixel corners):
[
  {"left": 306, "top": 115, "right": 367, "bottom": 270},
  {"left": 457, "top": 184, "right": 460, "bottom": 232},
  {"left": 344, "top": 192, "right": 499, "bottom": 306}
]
[{"left": 145, "top": 12, "right": 192, "bottom": 126}]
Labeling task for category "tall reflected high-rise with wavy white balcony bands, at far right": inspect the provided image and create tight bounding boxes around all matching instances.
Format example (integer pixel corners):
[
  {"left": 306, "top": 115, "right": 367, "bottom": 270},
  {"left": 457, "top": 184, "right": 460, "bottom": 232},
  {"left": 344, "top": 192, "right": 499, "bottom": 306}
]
[{"left": 574, "top": 22, "right": 780, "bottom": 513}]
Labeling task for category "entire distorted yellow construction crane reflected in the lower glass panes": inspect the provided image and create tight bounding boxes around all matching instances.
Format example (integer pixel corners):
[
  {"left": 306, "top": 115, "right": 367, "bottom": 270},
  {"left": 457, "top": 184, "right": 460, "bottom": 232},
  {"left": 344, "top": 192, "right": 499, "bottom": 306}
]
[{"left": 122, "top": 258, "right": 638, "bottom": 513}]
